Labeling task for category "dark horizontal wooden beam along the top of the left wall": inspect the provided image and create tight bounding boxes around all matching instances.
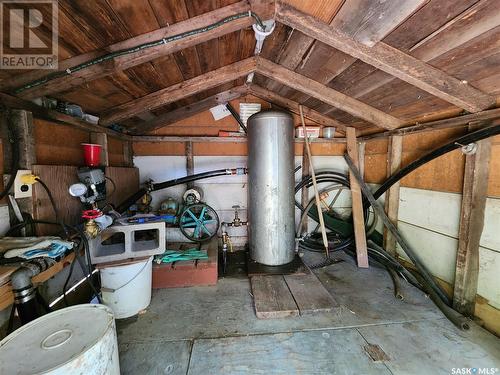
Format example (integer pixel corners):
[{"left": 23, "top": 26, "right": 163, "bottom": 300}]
[{"left": 0, "top": 92, "right": 131, "bottom": 140}]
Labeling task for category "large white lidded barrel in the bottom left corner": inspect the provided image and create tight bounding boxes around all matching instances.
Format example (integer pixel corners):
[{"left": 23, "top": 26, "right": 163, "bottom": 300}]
[{"left": 0, "top": 304, "right": 120, "bottom": 375}]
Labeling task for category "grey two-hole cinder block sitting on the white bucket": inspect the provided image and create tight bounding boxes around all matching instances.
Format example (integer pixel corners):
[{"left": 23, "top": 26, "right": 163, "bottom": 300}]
[{"left": 89, "top": 222, "right": 165, "bottom": 264}]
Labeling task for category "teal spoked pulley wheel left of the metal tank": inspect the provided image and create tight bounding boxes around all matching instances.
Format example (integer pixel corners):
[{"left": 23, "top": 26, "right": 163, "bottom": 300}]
[{"left": 179, "top": 203, "right": 220, "bottom": 242}]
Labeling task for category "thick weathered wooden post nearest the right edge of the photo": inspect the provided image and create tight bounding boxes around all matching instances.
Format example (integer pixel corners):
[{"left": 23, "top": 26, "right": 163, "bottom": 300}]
[{"left": 453, "top": 134, "right": 491, "bottom": 316}]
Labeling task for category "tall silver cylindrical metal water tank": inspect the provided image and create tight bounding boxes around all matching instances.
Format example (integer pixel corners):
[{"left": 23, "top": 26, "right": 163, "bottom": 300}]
[{"left": 248, "top": 110, "right": 295, "bottom": 266}]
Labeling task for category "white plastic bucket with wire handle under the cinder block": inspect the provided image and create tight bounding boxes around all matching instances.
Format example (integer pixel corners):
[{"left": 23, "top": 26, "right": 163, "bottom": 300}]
[{"left": 100, "top": 257, "right": 153, "bottom": 319}]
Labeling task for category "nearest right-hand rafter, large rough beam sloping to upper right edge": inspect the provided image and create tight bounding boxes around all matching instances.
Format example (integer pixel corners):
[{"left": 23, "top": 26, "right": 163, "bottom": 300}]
[{"left": 276, "top": 2, "right": 495, "bottom": 112}]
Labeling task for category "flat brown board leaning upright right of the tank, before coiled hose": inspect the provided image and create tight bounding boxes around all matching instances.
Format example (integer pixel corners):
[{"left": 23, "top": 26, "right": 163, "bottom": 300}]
[{"left": 346, "top": 127, "right": 368, "bottom": 268}]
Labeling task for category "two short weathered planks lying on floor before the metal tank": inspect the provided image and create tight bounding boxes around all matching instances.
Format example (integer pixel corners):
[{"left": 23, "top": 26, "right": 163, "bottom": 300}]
[{"left": 250, "top": 272, "right": 338, "bottom": 319}]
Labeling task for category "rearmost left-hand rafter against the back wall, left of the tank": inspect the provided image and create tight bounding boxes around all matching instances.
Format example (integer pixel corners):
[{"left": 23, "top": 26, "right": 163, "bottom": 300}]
[{"left": 127, "top": 86, "right": 248, "bottom": 135}]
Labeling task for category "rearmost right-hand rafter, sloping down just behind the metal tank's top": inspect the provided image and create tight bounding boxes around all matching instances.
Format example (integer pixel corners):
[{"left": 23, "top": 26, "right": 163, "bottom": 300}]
[{"left": 250, "top": 84, "right": 346, "bottom": 131}]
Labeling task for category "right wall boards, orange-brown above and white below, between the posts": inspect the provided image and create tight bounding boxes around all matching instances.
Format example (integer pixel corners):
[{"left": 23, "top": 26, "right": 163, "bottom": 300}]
[{"left": 365, "top": 128, "right": 500, "bottom": 335}]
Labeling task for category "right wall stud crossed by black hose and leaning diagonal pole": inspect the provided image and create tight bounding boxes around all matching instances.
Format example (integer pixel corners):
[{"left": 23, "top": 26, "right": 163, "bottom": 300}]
[{"left": 384, "top": 135, "right": 403, "bottom": 255}]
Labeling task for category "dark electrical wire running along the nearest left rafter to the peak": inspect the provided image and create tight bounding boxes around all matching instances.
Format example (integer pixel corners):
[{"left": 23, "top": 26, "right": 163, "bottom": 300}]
[{"left": 14, "top": 11, "right": 265, "bottom": 94}]
